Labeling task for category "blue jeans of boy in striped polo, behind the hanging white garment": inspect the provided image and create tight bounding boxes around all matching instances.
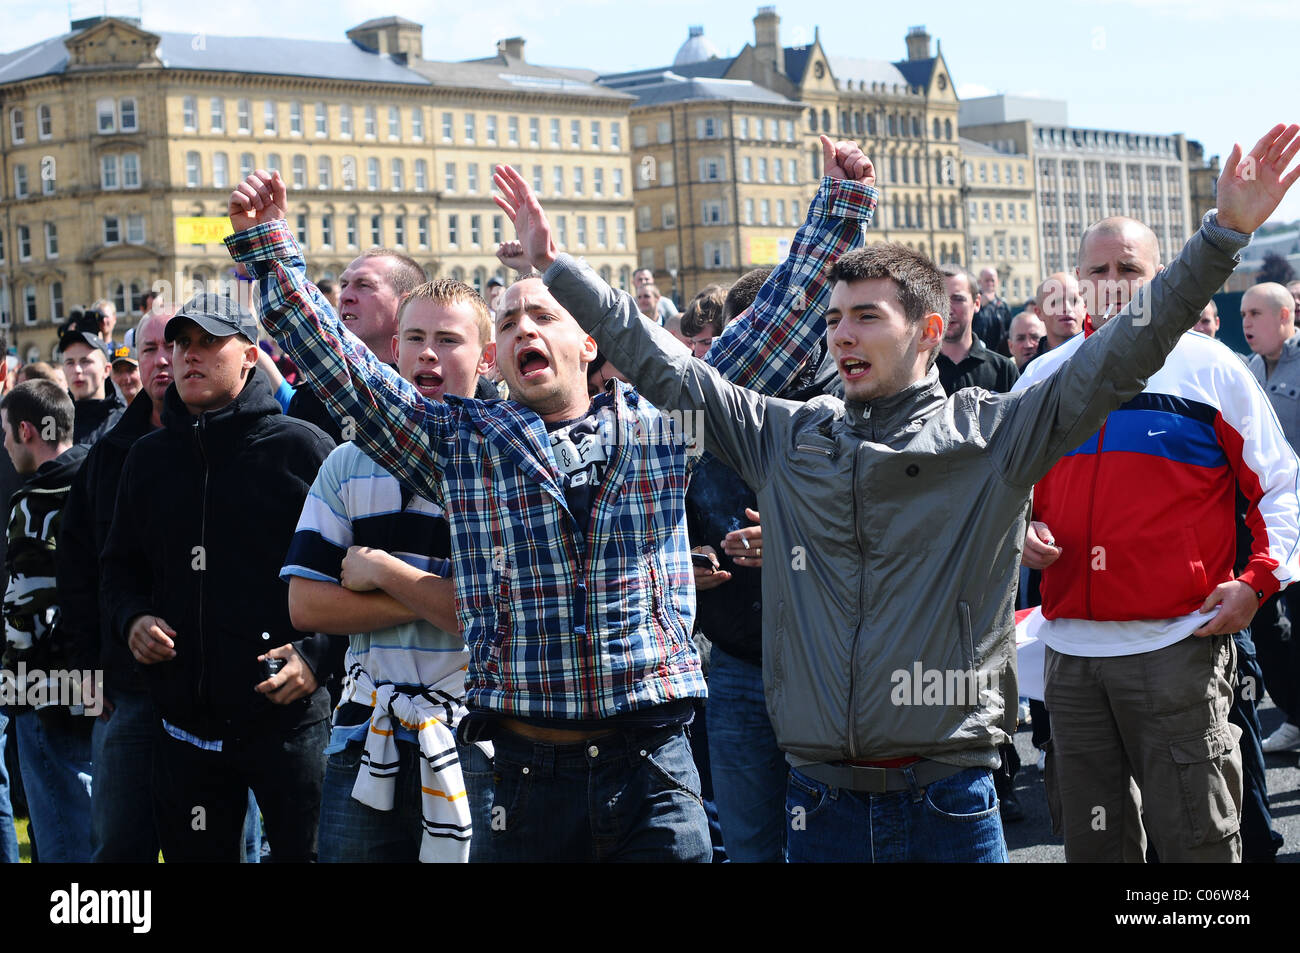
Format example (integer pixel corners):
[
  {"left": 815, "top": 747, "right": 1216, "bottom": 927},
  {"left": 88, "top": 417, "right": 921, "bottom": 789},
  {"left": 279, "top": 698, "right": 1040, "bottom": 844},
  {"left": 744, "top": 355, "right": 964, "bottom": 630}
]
[{"left": 320, "top": 741, "right": 493, "bottom": 863}]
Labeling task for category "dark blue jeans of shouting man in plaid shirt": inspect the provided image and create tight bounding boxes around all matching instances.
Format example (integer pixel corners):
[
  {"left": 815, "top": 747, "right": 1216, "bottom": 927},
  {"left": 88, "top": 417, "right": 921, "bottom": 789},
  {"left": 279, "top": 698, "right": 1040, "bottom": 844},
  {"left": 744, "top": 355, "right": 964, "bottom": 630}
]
[{"left": 476, "top": 728, "right": 712, "bottom": 863}]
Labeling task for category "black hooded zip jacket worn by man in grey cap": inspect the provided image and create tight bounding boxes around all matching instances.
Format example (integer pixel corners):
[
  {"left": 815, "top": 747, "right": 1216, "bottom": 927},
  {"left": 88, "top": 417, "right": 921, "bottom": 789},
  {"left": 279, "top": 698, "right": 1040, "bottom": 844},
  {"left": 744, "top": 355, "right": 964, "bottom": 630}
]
[{"left": 100, "top": 371, "right": 346, "bottom": 740}]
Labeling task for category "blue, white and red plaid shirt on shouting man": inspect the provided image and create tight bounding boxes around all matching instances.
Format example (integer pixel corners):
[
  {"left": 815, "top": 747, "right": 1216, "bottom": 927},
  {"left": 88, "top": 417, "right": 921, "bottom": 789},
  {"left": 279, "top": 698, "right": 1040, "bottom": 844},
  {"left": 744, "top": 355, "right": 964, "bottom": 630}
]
[{"left": 226, "top": 178, "right": 876, "bottom": 719}]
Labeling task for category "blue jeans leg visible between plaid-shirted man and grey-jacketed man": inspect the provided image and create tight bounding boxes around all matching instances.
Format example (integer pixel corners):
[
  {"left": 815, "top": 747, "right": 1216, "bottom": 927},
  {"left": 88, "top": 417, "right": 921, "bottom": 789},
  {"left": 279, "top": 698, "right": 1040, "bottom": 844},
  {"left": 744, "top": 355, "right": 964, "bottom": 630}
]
[{"left": 709, "top": 645, "right": 789, "bottom": 863}]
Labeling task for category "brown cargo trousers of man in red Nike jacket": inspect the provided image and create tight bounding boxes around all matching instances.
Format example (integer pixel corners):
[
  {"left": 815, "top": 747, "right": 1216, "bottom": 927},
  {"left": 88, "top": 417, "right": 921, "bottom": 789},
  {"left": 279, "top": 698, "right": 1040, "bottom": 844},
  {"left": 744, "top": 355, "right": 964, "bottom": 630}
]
[{"left": 1044, "top": 636, "right": 1242, "bottom": 863}]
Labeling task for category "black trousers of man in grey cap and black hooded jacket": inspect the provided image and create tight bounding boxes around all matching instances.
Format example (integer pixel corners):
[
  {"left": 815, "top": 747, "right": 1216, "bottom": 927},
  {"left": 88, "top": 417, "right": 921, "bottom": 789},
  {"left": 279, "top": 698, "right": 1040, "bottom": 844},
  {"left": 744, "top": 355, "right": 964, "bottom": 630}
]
[{"left": 153, "top": 719, "right": 329, "bottom": 863}]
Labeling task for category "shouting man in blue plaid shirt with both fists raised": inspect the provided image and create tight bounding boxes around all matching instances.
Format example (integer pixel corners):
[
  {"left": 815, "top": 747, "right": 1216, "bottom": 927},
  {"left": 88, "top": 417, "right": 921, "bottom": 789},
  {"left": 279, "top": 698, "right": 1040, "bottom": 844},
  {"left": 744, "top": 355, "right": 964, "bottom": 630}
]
[{"left": 228, "top": 140, "right": 876, "bottom": 861}]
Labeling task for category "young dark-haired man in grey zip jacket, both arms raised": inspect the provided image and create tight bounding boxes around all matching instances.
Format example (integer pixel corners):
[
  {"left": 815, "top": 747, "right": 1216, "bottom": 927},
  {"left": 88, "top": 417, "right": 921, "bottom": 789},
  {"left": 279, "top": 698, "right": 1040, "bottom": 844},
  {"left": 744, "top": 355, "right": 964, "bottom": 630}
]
[{"left": 497, "top": 126, "right": 1300, "bottom": 861}]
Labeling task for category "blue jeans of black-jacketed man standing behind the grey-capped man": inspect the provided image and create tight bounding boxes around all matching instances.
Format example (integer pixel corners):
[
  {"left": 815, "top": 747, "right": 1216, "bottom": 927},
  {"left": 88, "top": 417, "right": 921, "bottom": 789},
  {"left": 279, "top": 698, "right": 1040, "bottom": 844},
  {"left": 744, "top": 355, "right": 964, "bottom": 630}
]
[{"left": 90, "top": 692, "right": 159, "bottom": 863}]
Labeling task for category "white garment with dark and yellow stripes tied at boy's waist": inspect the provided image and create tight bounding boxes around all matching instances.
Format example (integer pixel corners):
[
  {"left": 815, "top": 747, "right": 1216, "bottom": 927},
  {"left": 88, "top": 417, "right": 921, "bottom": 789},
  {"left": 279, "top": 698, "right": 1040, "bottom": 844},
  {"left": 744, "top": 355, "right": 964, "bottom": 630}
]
[{"left": 345, "top": 657, "right": 491, "bottom": 863}]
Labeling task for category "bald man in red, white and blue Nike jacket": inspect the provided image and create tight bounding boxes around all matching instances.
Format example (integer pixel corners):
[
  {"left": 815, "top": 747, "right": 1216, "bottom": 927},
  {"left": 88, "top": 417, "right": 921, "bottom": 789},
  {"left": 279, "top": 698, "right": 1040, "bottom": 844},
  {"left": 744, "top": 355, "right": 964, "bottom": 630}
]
[{"left": 1017, "top": 212, "right": 1300, "bottom": 862}]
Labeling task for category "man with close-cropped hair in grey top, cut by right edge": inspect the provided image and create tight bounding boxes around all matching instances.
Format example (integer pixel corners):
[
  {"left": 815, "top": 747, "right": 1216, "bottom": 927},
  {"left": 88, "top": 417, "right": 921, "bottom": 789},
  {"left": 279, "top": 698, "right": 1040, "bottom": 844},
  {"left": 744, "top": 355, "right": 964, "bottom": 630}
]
[{"left": 1242, "top": 282, "right": 1300, "bottom": 754}]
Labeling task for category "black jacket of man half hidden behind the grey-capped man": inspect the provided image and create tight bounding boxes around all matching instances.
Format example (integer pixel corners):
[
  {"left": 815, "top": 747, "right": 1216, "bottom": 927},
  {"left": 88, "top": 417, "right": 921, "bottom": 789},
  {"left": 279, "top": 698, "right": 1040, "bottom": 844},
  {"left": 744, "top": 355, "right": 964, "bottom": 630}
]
[{"left": 59, "top": 387, "right": 153, "bottom": 692}]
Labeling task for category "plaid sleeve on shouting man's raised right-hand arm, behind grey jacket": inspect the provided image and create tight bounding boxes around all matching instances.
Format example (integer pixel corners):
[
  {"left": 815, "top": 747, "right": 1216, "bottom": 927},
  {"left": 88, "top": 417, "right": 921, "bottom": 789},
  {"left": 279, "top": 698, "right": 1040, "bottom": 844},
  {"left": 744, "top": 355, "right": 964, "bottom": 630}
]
[{"left": 705, "top": 177, "right": 880, "bottom": 395}]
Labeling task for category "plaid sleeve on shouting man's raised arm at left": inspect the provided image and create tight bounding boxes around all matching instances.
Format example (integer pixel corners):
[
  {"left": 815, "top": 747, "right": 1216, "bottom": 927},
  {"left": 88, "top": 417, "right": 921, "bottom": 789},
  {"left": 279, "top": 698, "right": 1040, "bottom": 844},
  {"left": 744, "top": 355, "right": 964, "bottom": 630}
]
[{"left": 225, "top": 220, "right": 452, "bottom": 503}]
